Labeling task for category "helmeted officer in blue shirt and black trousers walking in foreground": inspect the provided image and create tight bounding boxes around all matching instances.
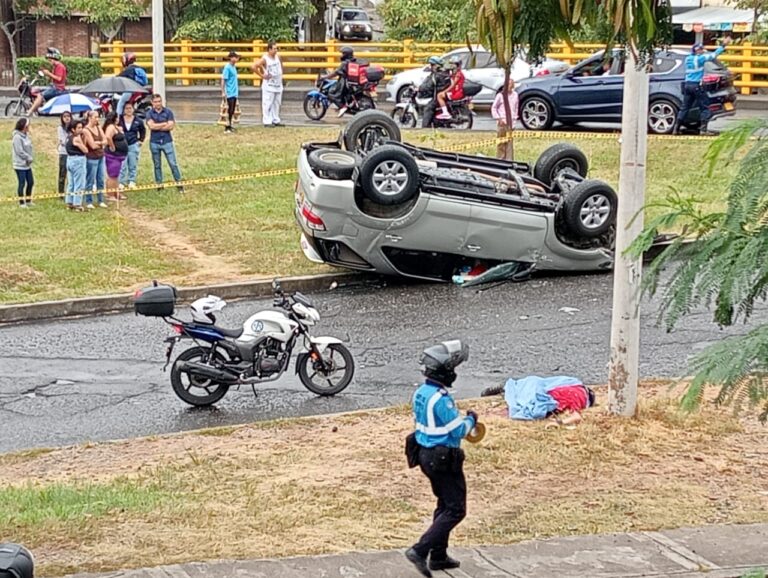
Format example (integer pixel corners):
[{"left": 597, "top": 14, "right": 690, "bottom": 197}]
[{"left": 405, "top": 340, "right": 477, "bottom": 577}]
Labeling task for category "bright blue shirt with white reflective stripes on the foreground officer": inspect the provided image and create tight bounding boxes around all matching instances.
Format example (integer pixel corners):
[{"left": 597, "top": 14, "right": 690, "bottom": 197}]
[{"left": 413, "top": 380, "right": 475, "bottom": 448}]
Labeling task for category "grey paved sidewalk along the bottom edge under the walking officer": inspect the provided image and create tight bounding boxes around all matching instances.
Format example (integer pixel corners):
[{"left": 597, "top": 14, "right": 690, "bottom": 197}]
[{"left": 66, "top": 520, "right": 768, "bottom": 578}]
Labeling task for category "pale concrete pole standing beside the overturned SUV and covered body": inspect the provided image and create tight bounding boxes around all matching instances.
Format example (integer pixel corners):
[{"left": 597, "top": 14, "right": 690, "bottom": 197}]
[{"left": 608, "top": 46, "right": 648, "bottom": 417}]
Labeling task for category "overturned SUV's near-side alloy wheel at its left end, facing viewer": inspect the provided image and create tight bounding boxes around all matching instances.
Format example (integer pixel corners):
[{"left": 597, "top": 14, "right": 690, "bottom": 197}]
[{"left": 360, "top": 145, "right": 419, "bottom": 206}]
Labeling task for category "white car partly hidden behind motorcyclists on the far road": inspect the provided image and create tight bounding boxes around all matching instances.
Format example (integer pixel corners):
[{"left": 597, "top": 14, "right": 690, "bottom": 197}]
[{"left": 387, "top": 47, "right": 569, "bottom": 104}]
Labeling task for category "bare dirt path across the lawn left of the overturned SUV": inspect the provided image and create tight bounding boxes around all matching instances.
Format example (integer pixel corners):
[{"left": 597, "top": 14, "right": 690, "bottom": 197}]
[{"left": 120, "top": 204, "right": 254, "bottom": 285}]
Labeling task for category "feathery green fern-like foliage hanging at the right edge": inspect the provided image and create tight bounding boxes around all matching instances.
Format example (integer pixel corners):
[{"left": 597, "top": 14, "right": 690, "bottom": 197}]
[{"left": 630, "top": 119, "right": 768, "bottom": 421}]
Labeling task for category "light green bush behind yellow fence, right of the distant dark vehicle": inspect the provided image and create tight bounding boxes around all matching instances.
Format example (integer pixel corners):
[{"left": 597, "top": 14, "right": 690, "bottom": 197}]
[{"left": 379, "top": 0, "right": 472, "bottom": 42}]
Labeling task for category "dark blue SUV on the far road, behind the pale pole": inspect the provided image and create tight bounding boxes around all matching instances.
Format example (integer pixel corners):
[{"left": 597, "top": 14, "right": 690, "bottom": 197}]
[{"left": 517, "top": 50, "right": 736, "bottom": 134}]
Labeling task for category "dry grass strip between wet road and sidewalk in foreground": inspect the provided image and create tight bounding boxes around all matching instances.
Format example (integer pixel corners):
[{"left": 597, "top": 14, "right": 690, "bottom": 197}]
[{"left": 0, "top": 383, "right": 768, "bottom": 576}]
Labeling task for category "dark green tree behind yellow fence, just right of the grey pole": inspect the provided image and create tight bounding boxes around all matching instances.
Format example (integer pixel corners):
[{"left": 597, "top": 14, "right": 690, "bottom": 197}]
[{"left": 174, "top": 0, "right": 307, "bottom": 42}]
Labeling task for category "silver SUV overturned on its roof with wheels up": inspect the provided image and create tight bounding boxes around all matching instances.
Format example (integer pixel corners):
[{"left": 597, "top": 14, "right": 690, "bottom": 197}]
[{"left": 295, "top": 111, "right": 617, "bottom": 281}]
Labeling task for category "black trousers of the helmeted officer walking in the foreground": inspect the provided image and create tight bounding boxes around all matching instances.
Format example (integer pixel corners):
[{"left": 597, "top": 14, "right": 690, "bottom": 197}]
[{"left": 413, "top": 448, "right": 467, "bottom": 560}]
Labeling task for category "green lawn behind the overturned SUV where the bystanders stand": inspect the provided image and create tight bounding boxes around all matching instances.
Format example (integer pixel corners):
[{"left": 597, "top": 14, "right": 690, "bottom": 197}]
[{"left": 0, "top": 119, "right": 735, "bottom": 303}]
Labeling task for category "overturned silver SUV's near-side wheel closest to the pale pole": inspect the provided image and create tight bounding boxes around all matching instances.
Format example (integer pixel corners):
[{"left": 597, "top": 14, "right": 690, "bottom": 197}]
[{"left": 560, "top": 180, "right": 619, "bottom": 239}]
